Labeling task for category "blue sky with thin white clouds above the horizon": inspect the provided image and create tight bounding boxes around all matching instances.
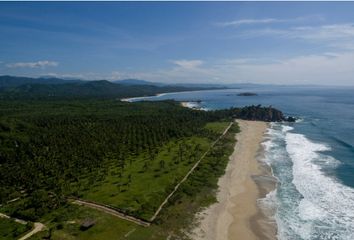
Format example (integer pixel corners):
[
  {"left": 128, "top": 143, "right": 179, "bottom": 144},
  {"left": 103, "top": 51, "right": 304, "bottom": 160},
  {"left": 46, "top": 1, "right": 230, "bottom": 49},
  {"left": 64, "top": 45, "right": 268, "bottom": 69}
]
[{"left": 0, "top": 2, "right": 354, "bottom": 85}]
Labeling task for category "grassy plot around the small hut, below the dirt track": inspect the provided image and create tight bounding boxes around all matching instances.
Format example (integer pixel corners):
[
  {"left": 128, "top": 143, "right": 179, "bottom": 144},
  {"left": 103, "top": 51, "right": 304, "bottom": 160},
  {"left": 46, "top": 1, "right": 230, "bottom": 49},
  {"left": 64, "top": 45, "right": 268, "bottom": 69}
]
[{"left": 30, "top": 205, "right": 154, "bottom": 240}]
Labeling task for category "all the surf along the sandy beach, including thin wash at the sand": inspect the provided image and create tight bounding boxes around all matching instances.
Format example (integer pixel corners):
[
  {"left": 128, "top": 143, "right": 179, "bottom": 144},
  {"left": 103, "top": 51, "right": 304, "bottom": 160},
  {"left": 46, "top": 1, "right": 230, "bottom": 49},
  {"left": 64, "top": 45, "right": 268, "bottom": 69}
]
[{"left": 259, "top": 124, "right": 354, "bottom": 240}]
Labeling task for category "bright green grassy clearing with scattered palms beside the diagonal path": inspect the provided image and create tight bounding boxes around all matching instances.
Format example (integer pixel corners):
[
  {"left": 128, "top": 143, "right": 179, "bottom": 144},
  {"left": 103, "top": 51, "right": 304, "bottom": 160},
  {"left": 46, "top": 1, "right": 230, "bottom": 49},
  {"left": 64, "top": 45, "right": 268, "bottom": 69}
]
[{"left": 82, "top": 137, "right": 212, "bottom": 220}]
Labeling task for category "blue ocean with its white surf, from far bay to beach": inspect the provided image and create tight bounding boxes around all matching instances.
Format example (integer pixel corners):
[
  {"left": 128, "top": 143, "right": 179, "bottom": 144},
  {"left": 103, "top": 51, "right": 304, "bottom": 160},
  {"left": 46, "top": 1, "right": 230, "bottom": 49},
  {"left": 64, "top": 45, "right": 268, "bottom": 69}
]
[{"left": 129, "top": 86, "right": 354, "bottom": 240}]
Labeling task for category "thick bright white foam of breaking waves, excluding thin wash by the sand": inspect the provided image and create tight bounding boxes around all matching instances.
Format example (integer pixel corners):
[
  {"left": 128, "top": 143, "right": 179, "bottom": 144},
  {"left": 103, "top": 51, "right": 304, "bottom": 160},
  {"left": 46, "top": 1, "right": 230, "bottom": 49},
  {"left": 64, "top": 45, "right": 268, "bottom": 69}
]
[{"left": 284, "top": 132, "right": 354, "bottom": 240}]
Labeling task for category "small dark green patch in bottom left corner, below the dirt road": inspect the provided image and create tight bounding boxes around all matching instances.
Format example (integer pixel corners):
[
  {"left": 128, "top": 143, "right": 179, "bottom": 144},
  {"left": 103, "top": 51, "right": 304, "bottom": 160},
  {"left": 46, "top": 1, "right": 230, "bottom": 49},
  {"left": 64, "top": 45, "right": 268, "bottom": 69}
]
[{"left": 0, "top": 218, "right": 32, "bottom": 240}]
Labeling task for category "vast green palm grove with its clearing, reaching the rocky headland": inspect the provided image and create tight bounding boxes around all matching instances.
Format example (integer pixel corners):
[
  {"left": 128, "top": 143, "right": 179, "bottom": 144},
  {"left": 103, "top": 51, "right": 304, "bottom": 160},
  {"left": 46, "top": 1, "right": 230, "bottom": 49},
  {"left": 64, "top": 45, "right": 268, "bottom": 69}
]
[{"left": 0, "top": 76, "right": 285, "bottom": 238}]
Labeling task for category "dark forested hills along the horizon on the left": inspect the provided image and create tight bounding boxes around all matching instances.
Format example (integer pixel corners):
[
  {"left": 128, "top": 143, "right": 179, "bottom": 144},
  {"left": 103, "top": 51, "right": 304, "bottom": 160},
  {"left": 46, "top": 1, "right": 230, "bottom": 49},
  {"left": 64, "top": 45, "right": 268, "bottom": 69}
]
[{"left": 0, "top": 76, "right": 221, "bottom": 100}]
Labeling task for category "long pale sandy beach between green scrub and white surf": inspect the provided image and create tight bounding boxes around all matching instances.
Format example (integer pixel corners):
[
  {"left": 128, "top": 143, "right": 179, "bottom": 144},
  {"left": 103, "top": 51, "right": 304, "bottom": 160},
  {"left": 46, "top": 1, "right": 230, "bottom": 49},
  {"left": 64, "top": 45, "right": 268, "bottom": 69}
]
[{"left": 191, "top": 120, "right": 276, "bottom": 240}]
